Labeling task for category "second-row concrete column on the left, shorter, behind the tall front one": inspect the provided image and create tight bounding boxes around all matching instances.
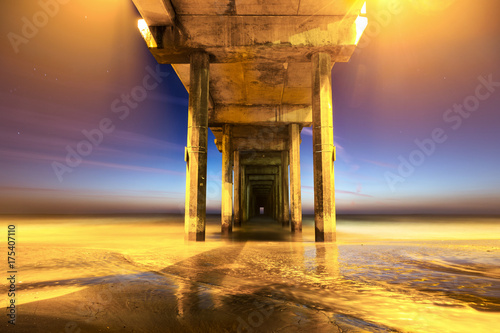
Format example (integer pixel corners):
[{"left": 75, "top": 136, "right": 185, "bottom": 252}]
[{"left": 221, "top": 124, "right": 233, "bottom": 234}]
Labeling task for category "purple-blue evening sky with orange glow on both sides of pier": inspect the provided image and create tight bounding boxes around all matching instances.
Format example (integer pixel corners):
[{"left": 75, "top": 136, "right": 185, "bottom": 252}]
[{"left": 0, "top": 0, "right": 500, "bottom": 214}]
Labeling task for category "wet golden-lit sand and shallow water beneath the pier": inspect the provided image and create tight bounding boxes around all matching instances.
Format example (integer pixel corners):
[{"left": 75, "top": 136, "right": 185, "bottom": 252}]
[{"left": 0, "top": 216, "right": 500, "bottom": 332}]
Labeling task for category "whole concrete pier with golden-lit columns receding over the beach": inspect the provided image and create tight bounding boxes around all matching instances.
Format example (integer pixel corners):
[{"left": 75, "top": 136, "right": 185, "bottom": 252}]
[{"left": 133, "top": 0, "right": 367, "bottom": 242}]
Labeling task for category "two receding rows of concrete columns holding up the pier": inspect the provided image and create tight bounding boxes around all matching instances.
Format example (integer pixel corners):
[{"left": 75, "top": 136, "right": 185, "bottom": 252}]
[{"left": 185, "top": 52, "right": 335, "bottom": 242}]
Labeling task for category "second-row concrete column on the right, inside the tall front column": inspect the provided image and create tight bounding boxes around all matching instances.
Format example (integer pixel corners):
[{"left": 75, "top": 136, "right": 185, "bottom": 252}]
[{"left": 288, "top": 124, "right": 302, "bottom": 232}]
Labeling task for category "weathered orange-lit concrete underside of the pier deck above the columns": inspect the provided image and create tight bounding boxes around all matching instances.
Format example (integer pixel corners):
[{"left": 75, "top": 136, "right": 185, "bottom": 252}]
[{"left": 134, "top": 0, "right": 364, "bottom": 132}]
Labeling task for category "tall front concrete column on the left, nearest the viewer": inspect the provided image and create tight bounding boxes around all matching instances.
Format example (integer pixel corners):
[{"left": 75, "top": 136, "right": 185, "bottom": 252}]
[{"left": 184, "top": 52, "right": 210, "bottom": 241}]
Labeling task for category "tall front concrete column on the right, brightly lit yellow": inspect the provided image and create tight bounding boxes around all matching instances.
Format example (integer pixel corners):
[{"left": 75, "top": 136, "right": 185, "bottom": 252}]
[{"left": 312, "top": 53, "right": 336, "bottom": 242}]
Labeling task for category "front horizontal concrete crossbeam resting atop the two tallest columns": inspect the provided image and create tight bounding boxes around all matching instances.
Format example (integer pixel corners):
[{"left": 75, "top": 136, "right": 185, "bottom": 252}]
[{"left": 146, "top": 14, "right": 362, "bottom": 64}]
